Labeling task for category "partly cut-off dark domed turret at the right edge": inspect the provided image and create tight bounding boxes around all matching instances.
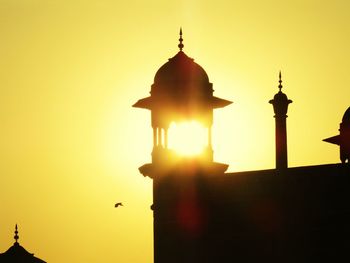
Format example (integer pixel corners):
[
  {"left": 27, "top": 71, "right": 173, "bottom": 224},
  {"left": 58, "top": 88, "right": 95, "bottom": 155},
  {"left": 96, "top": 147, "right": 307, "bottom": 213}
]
[{"left": 323, "top": 107, "right": 350, "bottom": 163}]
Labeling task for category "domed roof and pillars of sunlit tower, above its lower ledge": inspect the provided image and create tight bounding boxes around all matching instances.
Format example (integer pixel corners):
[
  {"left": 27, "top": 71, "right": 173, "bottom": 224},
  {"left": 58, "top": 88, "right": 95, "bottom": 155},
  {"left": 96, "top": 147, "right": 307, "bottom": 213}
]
[{"left": 133, "top": 29, "right": 232, "bottom": 167}]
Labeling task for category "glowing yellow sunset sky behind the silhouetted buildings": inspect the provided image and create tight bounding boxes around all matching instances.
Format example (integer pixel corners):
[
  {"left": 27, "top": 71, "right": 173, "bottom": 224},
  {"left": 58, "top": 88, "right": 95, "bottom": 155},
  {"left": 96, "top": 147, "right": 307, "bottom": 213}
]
[{"left": 0, "top": 0, "right": 350, "bottom": 263}]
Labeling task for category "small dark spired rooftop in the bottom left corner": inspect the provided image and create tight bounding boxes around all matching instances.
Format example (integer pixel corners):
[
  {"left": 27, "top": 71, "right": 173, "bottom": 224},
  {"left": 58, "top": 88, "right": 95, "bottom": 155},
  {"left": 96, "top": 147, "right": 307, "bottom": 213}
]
[{"left": 0, "top": 224, "right": 45, "bottom": 263}]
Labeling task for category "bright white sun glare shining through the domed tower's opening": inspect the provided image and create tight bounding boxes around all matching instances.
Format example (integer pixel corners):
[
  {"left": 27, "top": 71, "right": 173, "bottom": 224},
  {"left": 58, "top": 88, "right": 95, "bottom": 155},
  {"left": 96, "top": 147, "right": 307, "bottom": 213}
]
[{"left": 169, "top": 121, "right": 207, "bottom": 156}]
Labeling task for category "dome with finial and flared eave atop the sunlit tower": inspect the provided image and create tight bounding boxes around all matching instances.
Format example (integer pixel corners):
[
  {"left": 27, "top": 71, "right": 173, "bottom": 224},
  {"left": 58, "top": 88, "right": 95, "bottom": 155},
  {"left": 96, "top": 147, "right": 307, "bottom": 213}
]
[{"left": 133, "top": 30, "right": 232, "bottom": 112}]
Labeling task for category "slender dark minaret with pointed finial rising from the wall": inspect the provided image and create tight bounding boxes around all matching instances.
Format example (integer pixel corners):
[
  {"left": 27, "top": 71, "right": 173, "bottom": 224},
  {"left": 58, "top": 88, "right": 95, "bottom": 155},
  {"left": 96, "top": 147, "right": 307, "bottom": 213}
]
[{"left": 269, "top": 72, "right": 292, "bottom": 170}]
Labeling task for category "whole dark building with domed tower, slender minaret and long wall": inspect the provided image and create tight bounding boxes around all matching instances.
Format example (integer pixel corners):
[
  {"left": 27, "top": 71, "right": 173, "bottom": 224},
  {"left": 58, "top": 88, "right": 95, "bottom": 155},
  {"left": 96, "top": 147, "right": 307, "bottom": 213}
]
[{"left": 133, "top": 31, "right": 350, "bottom": 263}]
